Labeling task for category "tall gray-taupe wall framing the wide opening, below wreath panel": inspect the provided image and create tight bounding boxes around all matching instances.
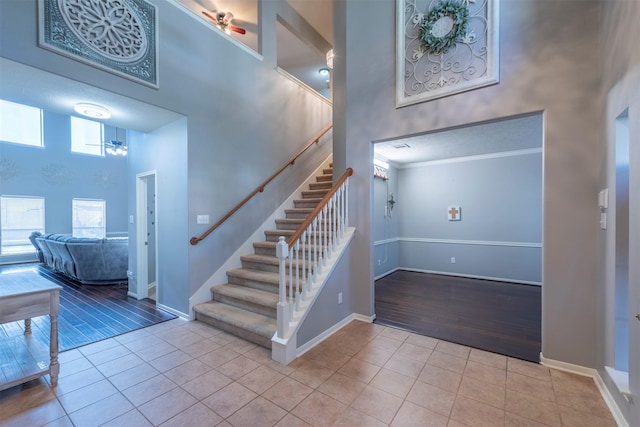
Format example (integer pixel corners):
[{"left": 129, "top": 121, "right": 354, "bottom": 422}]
[{"left": 334, "top": 0, "right": 601, "bottom": 367}]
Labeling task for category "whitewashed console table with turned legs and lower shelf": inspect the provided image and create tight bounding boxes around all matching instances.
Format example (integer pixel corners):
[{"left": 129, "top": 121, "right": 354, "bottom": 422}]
[{"left": 0, "top": 274, "right": 62, "bottom": 390}]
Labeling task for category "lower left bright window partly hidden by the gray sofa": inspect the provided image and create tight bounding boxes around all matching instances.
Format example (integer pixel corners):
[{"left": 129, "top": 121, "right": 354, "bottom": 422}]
[{"left": 0, "top": 196, "right": 44, "bottom": 255}]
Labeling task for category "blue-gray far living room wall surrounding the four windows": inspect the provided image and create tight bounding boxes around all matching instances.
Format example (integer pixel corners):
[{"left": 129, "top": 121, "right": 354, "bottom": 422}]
[{"left": 0, "top": 111, "right": 127, "bottom": 263}]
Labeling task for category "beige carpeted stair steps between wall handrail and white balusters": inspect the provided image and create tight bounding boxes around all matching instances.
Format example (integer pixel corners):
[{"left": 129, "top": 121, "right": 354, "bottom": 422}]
[{"left": 193, "top": 168, "right": 333, "bottom": 349}]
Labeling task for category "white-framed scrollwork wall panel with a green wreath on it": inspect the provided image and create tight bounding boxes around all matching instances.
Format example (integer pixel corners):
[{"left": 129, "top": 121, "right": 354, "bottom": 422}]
[{"left": 396, "top": 0, "right": 500, "bottom": 107}]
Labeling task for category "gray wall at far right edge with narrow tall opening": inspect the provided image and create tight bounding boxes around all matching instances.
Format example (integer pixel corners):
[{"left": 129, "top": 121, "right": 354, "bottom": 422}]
[{"left": 597, "top": 0, "right": 640, "bottom": 426}]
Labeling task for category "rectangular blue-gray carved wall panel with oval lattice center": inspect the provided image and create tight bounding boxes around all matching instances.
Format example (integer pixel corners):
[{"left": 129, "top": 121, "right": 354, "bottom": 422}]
[{"left": 38, "top": 0, "right": 158, "bottom": 88}]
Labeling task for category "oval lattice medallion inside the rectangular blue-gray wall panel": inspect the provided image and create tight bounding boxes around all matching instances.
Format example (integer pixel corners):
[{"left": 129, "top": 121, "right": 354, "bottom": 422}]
[{"left": 58, "top": 0, "right": 149, "bottom": 62}]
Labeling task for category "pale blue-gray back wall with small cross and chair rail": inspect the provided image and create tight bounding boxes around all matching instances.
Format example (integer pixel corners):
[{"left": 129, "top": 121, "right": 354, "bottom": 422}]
[{"left": 396, "top": 152, "right": 542, "bottom": 283}]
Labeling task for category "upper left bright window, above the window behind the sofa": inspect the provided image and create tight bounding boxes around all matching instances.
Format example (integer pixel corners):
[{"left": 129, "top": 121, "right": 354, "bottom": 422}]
[{"left": 0, "top": 99, "right": 44, "bottom": 147}]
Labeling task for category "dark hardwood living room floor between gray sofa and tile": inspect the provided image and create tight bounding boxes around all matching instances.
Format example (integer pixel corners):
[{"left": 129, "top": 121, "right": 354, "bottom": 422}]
[{"left": 0, "top": 264, "right": 177, "bottom": 353}]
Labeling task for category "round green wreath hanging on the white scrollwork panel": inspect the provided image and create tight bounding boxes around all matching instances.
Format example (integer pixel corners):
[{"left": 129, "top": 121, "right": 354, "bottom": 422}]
[{"left": 420, "top": 0, "right": 469, "bottom": 54}]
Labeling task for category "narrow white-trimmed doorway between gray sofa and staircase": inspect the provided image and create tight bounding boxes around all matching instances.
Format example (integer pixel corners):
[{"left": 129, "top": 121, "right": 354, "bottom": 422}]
[{"left": 136, "top": 171, "right": 161, "bottom": 302}]
